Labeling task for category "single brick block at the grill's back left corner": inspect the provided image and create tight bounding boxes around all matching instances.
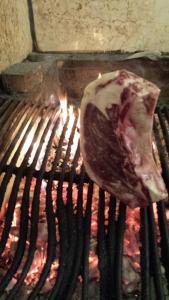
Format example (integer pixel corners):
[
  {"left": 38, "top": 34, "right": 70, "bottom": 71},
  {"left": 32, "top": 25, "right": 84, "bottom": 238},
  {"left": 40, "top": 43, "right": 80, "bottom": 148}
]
[{"left": 1, "top": 61, "right": 61, "bottom": 106}]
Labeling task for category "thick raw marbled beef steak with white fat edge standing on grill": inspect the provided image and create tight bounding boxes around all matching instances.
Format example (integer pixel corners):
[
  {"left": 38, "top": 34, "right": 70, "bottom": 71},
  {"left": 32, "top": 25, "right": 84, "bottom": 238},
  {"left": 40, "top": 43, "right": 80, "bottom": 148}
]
[{"left": 80, "top": 70, "right": 167, "bottom": 207}]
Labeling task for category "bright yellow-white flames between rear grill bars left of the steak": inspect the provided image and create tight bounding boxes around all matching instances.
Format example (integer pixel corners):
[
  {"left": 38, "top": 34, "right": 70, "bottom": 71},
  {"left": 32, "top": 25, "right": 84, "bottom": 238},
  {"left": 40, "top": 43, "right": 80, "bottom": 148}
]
[{"left": 13, "top": 95, "right": 81, "bottom": 171}]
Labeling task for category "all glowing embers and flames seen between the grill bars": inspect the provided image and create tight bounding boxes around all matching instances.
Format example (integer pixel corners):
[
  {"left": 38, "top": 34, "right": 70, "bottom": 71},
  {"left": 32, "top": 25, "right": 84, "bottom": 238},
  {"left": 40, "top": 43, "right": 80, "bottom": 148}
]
[{"left": 0, "top": 95, "right": 169, "bottom": 294}]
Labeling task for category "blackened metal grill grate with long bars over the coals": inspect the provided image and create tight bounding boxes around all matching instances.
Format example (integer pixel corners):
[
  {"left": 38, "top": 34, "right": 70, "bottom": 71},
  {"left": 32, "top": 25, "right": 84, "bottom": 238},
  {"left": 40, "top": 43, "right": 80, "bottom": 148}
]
[{"left": 0, "top": 99, "right": 169, "bottom": 300}]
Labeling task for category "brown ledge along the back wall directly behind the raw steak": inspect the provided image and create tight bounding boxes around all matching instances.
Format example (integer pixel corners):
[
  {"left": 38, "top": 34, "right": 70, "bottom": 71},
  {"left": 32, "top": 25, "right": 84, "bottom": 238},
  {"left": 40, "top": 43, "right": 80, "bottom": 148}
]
[{"left": 28, "top": 51, "right": 169, "bottom": 103}]
